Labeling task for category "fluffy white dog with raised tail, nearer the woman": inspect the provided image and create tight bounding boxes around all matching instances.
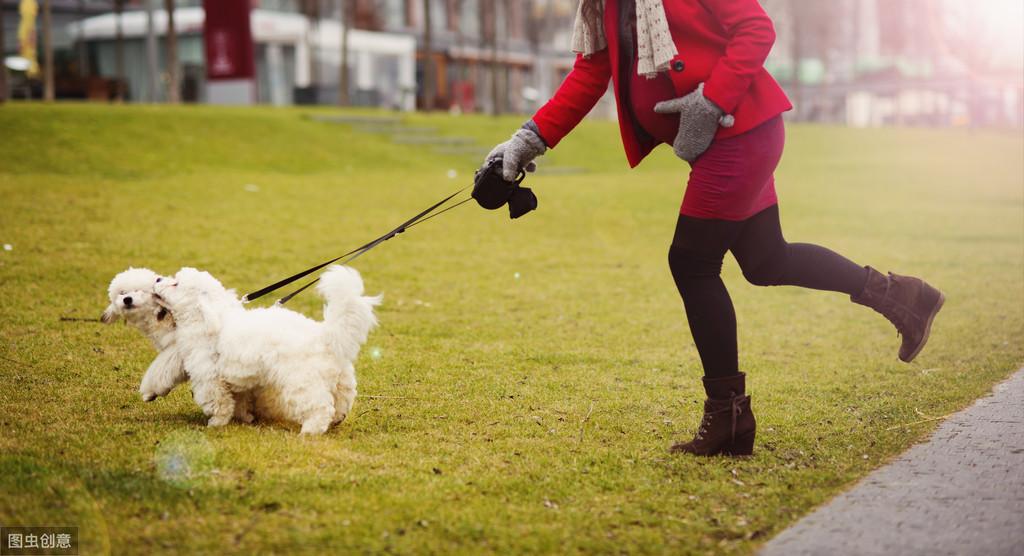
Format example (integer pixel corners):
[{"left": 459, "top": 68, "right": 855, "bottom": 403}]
[{"left": 155, "top": 265, "right": 381, "bottom": 434}]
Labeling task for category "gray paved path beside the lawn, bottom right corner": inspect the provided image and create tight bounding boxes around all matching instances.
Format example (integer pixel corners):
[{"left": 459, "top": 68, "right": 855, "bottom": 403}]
[{"left": 760, "top": 370, "right": 1024, "bottom": 556}]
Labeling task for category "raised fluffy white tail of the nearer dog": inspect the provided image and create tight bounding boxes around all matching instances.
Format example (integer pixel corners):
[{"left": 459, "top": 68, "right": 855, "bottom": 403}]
[{"left": 316, "top": 264, "right": 384, "bottom": 360}]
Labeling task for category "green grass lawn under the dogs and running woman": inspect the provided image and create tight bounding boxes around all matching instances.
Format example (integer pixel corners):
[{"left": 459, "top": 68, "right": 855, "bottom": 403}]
[{"left": 0, "top": 103, "right": 1024, "bottom": 554}]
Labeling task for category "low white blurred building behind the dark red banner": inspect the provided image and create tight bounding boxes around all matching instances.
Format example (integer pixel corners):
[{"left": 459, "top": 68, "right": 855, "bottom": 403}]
[{"left": 70, "top": 2, "right": 416, "bottom": 110}]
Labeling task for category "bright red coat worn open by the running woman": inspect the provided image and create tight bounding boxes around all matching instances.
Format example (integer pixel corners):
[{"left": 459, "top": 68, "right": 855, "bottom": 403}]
[{"left": 534, "top": 0, "right": 793, "bottom": 167}]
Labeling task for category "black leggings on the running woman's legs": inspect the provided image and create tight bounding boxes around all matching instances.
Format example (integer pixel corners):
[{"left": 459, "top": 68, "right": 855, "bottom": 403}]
[{"left": 669, "top": 205, "right": 867, "bottom": 377}]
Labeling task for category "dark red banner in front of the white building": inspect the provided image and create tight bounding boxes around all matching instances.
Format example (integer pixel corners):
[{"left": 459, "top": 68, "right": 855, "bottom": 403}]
[{"left": 203, "top": 0, "right": 256, "bottom": 81}]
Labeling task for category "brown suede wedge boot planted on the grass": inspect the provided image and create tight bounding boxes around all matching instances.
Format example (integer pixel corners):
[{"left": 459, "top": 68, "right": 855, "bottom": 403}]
[{"left": 670, "top": 373, "right": 757, "bottom": 456}]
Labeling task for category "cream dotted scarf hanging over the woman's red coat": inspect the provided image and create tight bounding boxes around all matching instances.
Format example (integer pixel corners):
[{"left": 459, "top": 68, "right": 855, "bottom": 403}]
[{"left": 572, "top": 0, "right": 679, "bottom": 79}]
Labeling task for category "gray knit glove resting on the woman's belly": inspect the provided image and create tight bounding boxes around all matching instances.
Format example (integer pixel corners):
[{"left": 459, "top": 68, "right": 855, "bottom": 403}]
[{"left": 654, "top": 83, "right": 735, "bottom": 163}]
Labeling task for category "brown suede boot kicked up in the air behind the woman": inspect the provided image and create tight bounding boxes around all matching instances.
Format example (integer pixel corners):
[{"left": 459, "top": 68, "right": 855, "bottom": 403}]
[{"left": 850, "top": 266, "right": 946, "bottom": 362}]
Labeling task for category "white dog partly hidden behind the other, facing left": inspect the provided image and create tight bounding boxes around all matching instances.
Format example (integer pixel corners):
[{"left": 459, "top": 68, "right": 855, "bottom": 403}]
[{"left": 100, "top": 268, "right": 188, "bottom": 401}]
